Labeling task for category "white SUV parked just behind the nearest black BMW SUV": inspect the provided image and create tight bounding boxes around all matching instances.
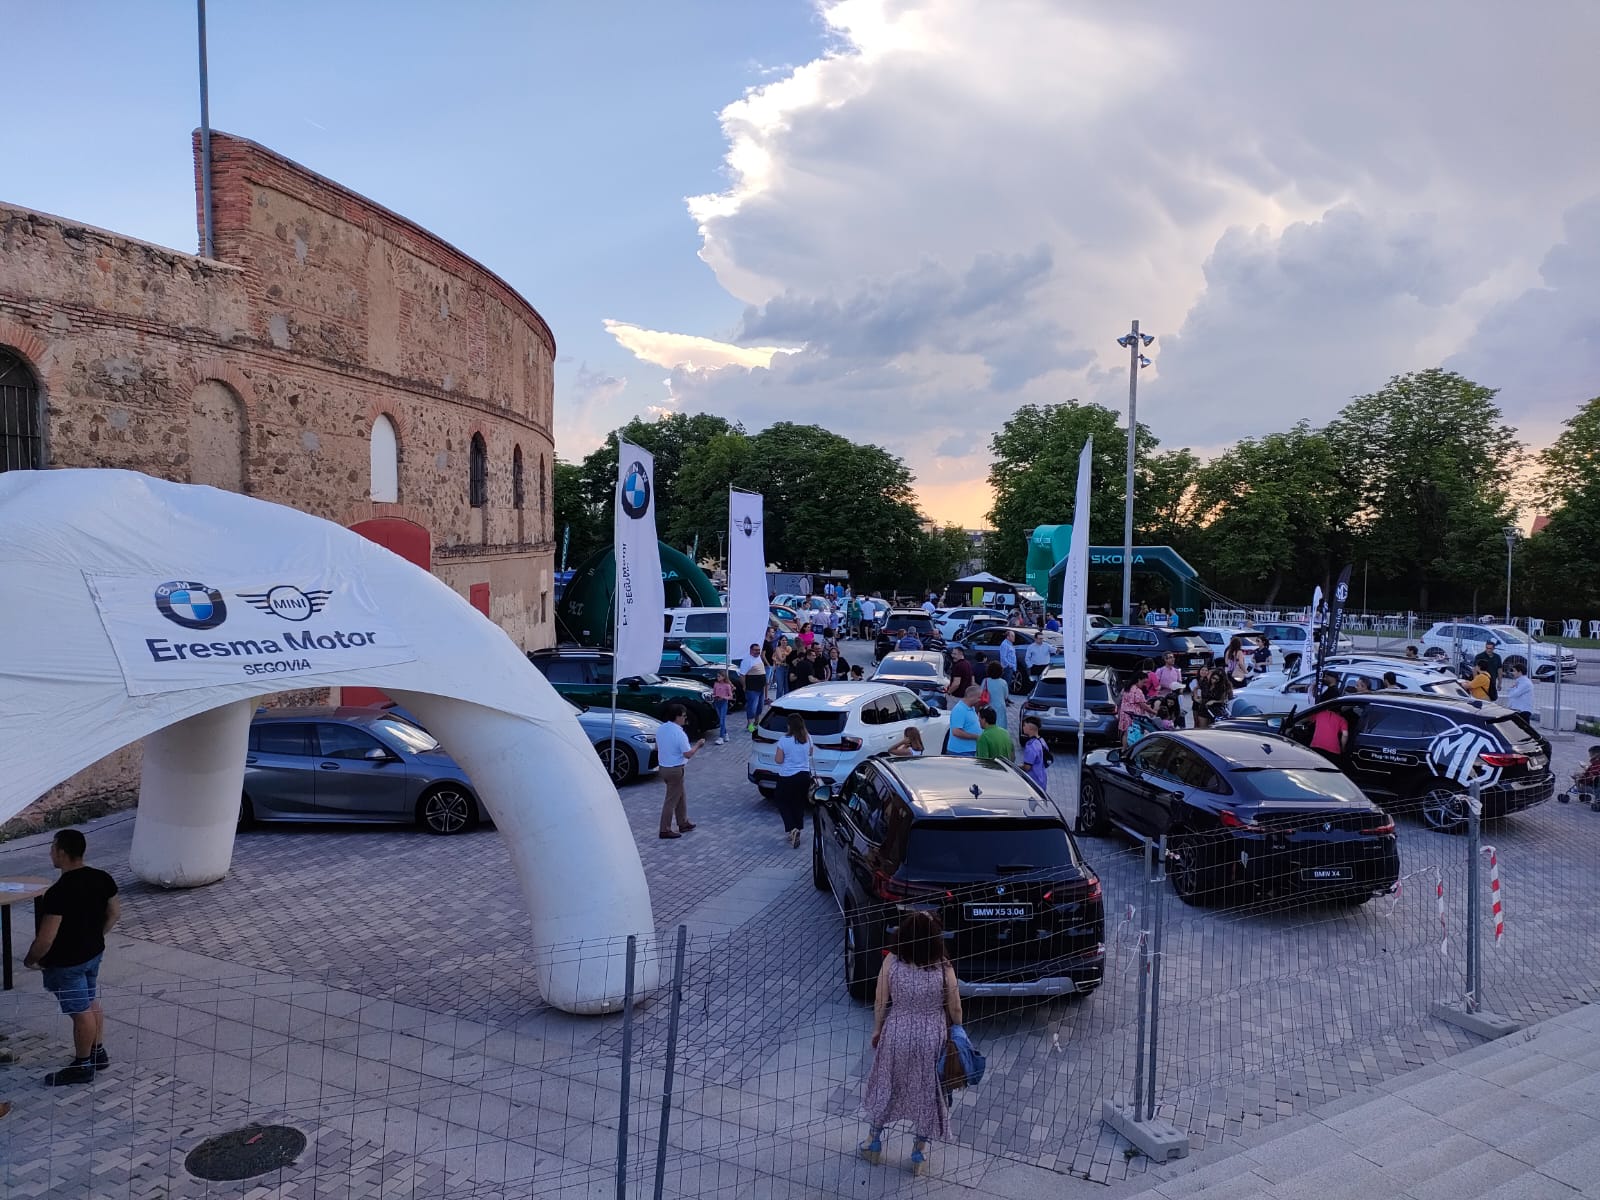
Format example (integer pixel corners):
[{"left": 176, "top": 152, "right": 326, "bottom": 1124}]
[{"left": 744, "top": 682, "right": 950, "bottom": 792}]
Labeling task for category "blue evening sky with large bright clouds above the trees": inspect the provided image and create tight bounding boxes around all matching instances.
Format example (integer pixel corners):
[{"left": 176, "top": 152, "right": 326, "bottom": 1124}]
[{"left": 12, "top": 0, "right": 1600, "bottom": 525}]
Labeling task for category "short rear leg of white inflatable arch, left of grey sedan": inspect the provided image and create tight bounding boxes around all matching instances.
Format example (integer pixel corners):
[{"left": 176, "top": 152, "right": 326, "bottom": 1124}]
[{"left": 128, "top": 699, "right": 256, "bottom": 888}]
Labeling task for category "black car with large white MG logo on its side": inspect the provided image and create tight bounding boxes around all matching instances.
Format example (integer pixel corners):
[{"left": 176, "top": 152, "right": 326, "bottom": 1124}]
[{"left": 1216, "top": 691, "right": 1555, "bottom": 832}]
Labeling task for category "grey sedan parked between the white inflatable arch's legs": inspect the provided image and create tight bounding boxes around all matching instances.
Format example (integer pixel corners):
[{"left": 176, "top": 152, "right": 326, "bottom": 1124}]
[{"left": 238, "top": 707, "right": 488, "bottom": 834}]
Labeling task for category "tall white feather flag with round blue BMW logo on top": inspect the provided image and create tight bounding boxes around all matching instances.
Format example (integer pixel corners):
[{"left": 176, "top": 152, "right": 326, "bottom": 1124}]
[{"left": 613, "top": 442, "right": 667, "bottom": 680}]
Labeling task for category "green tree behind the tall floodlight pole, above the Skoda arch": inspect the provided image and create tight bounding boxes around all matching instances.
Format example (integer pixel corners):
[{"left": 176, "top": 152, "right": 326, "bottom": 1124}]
[{"left": 984, "top": 400, "right": 1171, "bottom": 579}]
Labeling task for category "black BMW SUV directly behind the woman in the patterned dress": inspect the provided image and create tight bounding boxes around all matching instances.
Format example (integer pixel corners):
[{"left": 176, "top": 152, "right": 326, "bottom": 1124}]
[{"left": 811, "top": 755, "right": 1106, "bottom": 1000}]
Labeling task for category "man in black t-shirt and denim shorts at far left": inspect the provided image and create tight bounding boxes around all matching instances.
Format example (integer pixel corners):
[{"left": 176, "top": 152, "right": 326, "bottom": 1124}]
[{"left": 22, "top": 829, "right": 122, "bottom": 1086}]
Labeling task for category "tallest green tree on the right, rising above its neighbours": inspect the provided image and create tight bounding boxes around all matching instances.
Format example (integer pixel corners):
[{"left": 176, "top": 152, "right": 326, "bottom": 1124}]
[{"left": 1326, "top": 368, "right": 1522, "bottom": 611}]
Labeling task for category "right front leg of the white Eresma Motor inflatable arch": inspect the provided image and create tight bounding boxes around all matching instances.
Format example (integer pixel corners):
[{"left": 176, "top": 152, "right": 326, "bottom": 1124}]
[{"left": 389, "top": 688, "right": 661, "bottom": 1013}]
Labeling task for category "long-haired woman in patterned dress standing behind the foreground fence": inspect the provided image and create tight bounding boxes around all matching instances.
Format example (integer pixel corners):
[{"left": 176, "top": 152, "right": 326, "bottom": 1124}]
[{"left": 861, "top": 910, "right": 962, "bottom": 1174}]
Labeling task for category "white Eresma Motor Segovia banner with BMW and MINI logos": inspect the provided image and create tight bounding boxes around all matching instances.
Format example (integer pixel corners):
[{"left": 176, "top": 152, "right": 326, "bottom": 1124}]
[{"left": 83, "top": 571, "right": 416, "bottom": 696}]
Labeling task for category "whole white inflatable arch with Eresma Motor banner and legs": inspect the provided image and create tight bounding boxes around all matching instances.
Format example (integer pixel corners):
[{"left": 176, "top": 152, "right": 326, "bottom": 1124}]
[{"left": 0, "top": 470, "right": 658, "bottom": 1013}]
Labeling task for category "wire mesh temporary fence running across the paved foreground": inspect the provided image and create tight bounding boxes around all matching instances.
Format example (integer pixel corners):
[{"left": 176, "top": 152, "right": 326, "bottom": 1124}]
[{"left": 0, "top": 739, "right": 1600, "bottom": 1200}]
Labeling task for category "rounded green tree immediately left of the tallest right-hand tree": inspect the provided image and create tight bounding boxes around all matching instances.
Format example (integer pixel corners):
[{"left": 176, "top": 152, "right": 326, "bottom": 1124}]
[{"left": 1190, "top": 421, "right": 1360, "bottom": 605}]
